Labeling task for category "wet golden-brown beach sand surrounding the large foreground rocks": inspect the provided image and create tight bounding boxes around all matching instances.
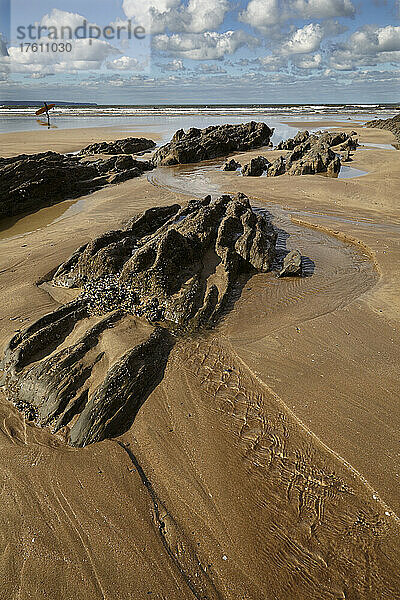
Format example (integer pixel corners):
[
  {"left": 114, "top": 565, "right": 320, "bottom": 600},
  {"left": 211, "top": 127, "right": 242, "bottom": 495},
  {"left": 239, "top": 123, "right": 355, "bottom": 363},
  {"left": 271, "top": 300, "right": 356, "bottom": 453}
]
[{"left": 0, "top": 123, "right": 400, "bottom": 600}]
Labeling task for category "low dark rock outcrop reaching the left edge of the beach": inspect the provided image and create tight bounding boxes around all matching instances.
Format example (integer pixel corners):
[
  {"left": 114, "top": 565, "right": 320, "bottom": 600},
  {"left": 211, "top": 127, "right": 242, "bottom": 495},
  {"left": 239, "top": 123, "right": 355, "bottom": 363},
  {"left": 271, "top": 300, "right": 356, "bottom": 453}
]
[{"left": 0, "top": 152, "right": 153, "bottom": 218}]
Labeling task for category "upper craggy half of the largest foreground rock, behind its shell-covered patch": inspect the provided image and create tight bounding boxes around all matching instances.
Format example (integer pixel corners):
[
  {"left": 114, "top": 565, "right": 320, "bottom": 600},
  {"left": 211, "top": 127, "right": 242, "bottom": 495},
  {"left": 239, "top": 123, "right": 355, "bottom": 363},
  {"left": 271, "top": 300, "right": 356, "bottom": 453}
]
[{"left": 65, "top": 195, "right": 275, "bottom": 329}]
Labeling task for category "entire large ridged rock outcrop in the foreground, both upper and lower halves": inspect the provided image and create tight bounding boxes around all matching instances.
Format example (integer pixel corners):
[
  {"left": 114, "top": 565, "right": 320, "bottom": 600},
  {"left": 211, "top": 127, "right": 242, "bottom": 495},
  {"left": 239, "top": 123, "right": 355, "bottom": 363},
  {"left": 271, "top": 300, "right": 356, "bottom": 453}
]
[{"left": 1, "top": 194, "right": 276, "bottom": 446}]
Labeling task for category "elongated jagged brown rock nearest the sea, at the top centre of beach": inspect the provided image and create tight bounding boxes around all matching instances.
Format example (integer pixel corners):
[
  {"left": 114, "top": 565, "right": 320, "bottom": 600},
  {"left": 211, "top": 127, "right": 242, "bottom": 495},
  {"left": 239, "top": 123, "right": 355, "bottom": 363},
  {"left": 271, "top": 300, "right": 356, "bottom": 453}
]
[{"left": 153, "top": 121, "right": 274, "bottom": 165}]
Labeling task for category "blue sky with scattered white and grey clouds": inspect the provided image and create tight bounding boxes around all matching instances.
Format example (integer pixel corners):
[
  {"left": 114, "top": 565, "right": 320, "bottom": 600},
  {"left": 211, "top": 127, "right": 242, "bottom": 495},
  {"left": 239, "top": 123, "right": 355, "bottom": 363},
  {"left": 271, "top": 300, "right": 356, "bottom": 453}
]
[{"left": 0, "top": 0, "right": 400, "bottom": 104}]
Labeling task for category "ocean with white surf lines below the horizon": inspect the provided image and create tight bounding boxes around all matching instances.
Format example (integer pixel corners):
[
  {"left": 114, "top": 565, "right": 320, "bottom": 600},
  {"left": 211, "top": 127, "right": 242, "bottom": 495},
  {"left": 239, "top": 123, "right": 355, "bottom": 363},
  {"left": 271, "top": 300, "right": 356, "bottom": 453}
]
[{"left": 0, "top": 103, "right": 398, "bottom": 142}]
